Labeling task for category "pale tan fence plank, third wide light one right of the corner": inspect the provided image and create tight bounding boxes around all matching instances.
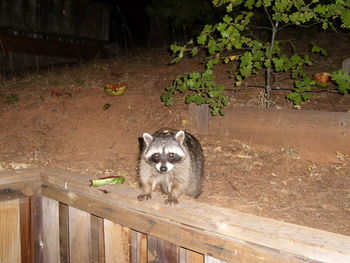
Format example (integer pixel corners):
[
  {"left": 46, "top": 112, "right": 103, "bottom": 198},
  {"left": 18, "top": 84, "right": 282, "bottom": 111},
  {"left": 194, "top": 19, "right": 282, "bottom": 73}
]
[{"left": 103, "top": 219, "right": 131, "bottom": 263}]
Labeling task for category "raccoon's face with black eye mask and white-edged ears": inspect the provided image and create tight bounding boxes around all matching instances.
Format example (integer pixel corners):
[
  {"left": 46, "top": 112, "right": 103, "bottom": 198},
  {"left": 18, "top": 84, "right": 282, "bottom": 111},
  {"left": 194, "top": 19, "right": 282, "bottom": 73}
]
[{"left": 143, "top": 131, "right": 186, "bottom": 173}]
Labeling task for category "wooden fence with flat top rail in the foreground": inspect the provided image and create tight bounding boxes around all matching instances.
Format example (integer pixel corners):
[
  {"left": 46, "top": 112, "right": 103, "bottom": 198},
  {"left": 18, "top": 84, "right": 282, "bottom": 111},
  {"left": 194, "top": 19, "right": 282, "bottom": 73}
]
[{"left": 0, "top": 168, "right": 350, "bottom": 263}]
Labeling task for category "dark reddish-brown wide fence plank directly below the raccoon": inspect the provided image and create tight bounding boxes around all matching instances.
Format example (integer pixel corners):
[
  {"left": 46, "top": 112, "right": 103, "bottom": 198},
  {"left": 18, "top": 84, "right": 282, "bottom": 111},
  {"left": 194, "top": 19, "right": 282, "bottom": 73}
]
[{"left": 147, "top": 235, "right": 180, "bottom": 263}]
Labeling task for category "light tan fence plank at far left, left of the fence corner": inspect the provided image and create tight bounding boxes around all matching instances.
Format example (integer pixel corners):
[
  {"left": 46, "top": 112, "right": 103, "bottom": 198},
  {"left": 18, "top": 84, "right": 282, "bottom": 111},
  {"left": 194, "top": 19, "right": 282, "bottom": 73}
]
[{"left": 0, "top": 199, "right": 21, "bottom": 263}]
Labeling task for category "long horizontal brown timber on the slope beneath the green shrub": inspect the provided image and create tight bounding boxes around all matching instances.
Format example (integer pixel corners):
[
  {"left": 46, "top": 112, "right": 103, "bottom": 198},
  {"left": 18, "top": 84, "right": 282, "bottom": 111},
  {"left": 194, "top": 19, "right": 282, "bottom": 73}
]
[{"left": 209, "top": 106, "right": 350, "bottom": 163}]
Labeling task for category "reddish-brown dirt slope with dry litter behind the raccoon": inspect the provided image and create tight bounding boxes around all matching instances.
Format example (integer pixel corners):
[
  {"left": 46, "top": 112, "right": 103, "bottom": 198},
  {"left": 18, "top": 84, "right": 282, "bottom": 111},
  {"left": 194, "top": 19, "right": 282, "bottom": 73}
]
[{"left": 0, "top": 33, "right": 350, "bottom": 235}]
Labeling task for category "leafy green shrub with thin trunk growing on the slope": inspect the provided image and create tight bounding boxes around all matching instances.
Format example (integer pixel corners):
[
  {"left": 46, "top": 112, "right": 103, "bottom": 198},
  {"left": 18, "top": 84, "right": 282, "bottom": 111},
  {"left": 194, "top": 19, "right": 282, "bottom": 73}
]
[{"left": 161, "top": 0, "right": 350, "bottom": 115}]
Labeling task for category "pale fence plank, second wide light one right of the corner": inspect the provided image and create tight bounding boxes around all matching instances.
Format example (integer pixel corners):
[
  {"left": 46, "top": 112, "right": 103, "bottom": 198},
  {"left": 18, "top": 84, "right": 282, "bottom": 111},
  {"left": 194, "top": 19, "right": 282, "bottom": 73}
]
[{"left": 69, "top": 207, "right": 91, "bottom": 263}]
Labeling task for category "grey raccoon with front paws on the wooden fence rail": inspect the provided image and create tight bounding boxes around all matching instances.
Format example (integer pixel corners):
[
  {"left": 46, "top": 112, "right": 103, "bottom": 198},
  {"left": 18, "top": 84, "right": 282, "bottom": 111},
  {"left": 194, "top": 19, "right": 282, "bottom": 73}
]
[{"left": 138, "top": 128, "right": 204, "bottom": 204}]
